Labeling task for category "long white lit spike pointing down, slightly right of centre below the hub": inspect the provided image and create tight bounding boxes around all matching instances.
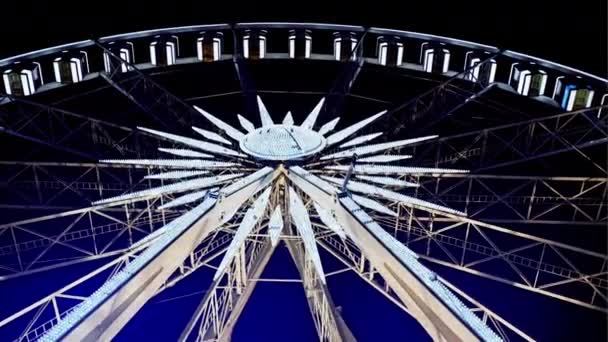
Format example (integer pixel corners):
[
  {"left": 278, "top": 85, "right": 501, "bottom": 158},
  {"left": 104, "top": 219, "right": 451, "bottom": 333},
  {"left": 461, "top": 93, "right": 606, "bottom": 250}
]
[{"left": 289, "top": 187, "right": 325, "bottom": 284}]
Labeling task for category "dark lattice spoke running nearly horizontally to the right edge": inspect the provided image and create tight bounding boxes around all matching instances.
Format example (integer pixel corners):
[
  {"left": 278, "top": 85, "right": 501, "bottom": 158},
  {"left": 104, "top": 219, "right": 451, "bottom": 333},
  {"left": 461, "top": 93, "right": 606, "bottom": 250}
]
[{"left": 416, "top": 174, "right": 608, "bottom": 227}]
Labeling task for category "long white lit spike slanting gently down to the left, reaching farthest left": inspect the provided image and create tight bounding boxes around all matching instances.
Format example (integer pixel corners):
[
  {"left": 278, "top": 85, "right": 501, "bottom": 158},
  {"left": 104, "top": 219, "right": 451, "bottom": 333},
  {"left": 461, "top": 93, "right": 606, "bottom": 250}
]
[{"left": 93, "top": 173, "right": 243, "bottom": 204}]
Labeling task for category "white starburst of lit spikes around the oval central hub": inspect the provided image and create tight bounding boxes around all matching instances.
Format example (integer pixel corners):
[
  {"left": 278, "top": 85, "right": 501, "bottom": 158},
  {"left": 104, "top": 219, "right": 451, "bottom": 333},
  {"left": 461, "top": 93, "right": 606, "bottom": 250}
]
[{"left": 94, "top": 96, "right": 467, "bottom": 282}]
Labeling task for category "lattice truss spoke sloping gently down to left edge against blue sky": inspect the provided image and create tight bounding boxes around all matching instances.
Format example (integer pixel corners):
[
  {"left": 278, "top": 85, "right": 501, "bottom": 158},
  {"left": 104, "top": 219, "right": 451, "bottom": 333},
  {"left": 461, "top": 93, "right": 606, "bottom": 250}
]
[{"left": 0, "top": 198, "right": 181, "bottom": 281}]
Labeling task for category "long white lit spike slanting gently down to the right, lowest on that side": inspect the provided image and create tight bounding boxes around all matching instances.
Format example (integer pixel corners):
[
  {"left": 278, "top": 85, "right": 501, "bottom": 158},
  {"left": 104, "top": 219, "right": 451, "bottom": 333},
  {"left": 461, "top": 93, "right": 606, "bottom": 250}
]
[{"left": 321, "top": 176, "right": 465, "bottom": 216}]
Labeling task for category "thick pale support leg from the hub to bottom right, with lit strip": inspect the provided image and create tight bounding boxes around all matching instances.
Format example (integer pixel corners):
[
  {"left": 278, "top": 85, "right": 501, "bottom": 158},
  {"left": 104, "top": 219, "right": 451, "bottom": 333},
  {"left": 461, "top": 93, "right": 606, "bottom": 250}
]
[{"left": 287, "top": 168, "right": 500, "bottom": 340}]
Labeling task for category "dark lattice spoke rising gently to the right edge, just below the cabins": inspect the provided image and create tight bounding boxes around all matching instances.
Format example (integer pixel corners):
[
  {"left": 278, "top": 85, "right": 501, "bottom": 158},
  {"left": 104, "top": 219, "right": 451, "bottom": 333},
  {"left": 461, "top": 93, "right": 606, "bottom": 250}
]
[{"left": 414, "top": 107, "right": 608, "bottom": 175}]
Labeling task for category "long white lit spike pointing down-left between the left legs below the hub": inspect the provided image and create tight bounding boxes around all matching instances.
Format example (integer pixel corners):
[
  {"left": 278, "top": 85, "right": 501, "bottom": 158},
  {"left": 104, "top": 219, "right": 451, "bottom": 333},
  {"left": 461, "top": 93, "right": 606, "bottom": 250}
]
[{"left": 213, "top": 187, "right": 272, "bottom": 281}]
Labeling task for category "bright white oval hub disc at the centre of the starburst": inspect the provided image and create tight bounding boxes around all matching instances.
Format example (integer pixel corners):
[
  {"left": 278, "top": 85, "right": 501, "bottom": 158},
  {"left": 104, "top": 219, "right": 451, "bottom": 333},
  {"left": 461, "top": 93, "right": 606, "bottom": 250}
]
[{"left": 240, "top": 125, "right": 326, "bottom": 161}]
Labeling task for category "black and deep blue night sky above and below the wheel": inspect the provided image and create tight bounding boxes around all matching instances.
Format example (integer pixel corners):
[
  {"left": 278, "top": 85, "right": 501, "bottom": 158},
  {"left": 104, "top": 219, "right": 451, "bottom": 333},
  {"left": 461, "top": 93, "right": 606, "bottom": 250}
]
[{"left": 0, "top": 0, "right": 607, "bottom": 342}]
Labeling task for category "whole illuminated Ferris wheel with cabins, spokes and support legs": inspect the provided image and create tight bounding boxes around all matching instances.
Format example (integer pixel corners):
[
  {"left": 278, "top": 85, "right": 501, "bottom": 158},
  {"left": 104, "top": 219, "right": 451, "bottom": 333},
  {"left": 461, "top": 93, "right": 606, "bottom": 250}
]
[{"left": 0, "top": 23, "right": 608, "bottom": 341}]
